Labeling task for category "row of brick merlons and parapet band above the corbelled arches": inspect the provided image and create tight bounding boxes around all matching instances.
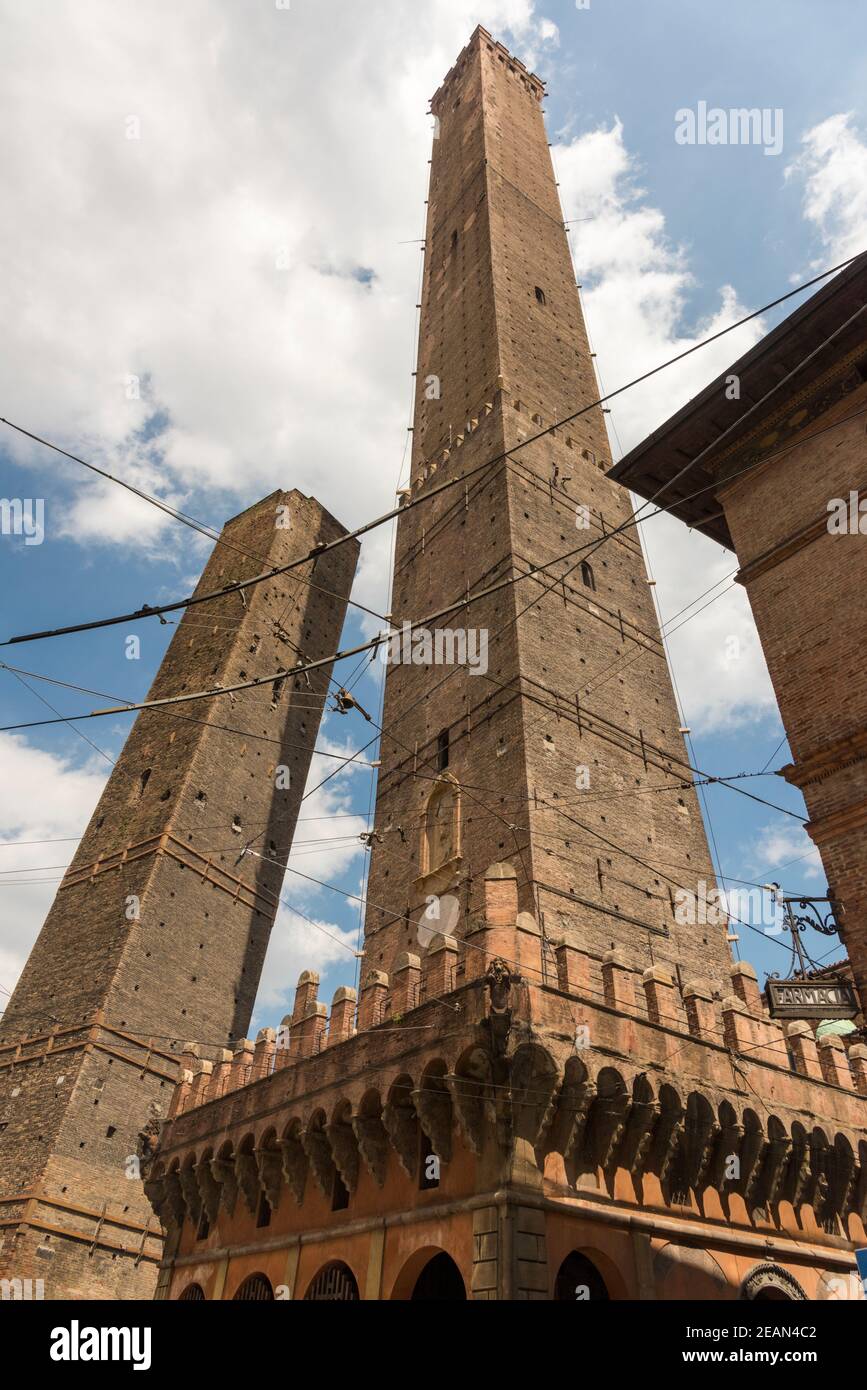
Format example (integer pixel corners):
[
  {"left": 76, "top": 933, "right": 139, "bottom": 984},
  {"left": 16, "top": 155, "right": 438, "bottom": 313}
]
[{"left": 163, "top": 863, "right": 867, "bottom": 1116}]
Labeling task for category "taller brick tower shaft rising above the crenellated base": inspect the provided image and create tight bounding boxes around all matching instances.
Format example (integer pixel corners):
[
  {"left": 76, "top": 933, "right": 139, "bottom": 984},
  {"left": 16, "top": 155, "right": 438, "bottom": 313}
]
[{"left": 367, "top": 29, "right": 731, "bottom": 986}]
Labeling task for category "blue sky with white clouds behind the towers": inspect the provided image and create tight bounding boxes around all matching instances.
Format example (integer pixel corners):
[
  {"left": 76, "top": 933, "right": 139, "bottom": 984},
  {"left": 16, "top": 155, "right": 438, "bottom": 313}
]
[{"left": 0, "top": 0, "right": 867, "bottom": 1026}]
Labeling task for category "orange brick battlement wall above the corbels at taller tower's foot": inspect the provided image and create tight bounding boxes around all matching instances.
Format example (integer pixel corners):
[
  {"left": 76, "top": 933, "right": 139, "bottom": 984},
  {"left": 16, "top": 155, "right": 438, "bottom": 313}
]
[{"left": 161, "top": 865, "right": 867, "bottom": 1156}]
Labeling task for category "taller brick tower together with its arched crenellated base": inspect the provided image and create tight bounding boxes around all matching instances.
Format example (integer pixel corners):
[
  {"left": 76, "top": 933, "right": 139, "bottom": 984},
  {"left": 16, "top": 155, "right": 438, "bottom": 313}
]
[{"left": 146, "top": 28, "right": 867, "bottom": 1300}]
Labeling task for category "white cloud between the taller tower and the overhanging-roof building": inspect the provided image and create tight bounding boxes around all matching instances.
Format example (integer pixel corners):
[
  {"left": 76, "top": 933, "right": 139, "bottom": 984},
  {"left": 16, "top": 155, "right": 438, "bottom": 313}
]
[{"left": 553, "top": 121, "right": 775, "bottom": 733}]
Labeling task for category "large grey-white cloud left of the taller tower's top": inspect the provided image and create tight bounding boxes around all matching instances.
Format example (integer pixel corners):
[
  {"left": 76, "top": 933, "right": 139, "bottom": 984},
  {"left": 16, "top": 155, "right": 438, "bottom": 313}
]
[{"left": 0, "top": 0, "right": 557, "bottom": 575}]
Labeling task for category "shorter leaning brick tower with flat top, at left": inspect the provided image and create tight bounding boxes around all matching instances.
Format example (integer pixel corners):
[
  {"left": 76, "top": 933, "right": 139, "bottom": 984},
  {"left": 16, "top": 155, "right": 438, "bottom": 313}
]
[{"left": 0, "top": 492, "right": 357, "bottom": 1298}]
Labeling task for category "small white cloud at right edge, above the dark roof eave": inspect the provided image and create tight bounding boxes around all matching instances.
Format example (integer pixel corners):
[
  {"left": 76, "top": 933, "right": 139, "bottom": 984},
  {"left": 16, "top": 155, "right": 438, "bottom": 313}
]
[{"left": 785, "top": 111, "right": 867, "bottom": 265}]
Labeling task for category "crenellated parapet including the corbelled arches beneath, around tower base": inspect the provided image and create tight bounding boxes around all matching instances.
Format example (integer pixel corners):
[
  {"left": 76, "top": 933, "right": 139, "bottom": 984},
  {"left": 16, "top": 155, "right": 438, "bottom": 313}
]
[{"left": 149, "top": 865, "right": 867, "bottom": 1262}]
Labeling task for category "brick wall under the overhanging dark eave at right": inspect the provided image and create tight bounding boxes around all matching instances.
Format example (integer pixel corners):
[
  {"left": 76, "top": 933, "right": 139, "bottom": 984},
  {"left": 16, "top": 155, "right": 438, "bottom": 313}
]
[{"left": 721, "top": 385, "right": 867, "bottom": 999}]
